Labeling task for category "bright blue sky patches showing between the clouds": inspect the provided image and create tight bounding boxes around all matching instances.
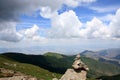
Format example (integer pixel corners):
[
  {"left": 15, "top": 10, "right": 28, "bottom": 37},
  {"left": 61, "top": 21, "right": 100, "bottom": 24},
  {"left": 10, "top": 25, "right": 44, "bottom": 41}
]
[{"left": 17, "top": 0, "right": 120, "bottom": 30}]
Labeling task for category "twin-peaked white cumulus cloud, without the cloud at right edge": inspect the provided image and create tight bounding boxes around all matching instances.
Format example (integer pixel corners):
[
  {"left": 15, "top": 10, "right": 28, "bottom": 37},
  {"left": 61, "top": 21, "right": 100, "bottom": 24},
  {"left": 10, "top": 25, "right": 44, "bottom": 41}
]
[{"left": 47, "top": 10, "right": 110, "bottom": 39}]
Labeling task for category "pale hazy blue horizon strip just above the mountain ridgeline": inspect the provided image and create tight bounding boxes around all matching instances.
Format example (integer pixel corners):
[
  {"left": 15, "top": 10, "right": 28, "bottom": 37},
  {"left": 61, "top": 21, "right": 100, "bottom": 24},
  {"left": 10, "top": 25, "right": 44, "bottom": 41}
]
[{"left": 0, "top": 46, "right": 120, "bottom": 55}]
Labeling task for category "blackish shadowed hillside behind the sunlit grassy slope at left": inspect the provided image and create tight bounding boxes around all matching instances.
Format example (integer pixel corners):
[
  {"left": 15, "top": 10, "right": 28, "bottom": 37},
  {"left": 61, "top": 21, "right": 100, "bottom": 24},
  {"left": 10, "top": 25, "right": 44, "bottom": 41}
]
[{"left": 2, "top": 53, "right": 66, "bottom": 73}]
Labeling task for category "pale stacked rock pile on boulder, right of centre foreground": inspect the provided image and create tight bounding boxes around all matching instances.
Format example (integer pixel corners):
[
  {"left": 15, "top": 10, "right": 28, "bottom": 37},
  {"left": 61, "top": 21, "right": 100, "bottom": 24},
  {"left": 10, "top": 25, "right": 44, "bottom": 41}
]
[{"left": 60, "top": 55, "right": 89, "bottom": 80}]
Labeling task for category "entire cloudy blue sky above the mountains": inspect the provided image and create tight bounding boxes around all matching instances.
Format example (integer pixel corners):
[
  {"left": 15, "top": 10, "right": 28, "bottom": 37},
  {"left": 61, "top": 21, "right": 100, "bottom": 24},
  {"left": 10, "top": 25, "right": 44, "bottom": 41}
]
[{"left": 0, "top": 0, "right": 120, "bottom": 54}]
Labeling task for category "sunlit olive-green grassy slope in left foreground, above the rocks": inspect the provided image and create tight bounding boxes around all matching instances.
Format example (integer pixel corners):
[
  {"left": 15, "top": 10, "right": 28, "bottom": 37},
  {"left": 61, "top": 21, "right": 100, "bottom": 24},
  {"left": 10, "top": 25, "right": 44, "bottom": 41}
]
[{"left": 0, "top": 55, "right": 61, "bottom": 80}]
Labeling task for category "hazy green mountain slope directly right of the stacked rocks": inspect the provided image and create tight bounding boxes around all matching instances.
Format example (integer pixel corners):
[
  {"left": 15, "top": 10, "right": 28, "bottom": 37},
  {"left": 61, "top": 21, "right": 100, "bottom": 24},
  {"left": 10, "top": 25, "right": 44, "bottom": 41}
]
[{"left": 82, "top": 57, "right": 120, "bottom": 77}]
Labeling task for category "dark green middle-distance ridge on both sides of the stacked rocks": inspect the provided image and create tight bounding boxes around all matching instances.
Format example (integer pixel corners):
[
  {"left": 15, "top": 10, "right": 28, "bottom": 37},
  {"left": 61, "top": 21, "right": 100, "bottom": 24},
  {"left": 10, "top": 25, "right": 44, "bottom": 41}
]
[{"left": 0, "top": 52, "right": 120, "bottom": 78}]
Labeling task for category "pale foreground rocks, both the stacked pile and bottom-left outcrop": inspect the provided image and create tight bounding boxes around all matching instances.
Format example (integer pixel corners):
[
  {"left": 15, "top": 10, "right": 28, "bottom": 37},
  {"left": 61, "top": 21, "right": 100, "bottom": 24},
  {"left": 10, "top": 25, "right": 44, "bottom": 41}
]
[{"left": 0, "top": 55, "right": 89, "bottom": 80}]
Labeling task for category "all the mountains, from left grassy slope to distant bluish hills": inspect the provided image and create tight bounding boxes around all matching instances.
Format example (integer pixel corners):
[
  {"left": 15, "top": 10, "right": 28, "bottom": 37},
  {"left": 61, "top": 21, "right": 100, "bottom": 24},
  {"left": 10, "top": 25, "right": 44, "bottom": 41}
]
[{"left": 0, "top": 49, "right": 120, "bottom": 80}]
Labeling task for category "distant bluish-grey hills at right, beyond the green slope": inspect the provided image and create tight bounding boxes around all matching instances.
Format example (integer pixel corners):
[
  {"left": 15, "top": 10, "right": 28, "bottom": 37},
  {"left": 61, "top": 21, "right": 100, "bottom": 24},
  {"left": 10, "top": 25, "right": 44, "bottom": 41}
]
[{"left": 80, "top": 48, "right": 120, "bottom": 66}]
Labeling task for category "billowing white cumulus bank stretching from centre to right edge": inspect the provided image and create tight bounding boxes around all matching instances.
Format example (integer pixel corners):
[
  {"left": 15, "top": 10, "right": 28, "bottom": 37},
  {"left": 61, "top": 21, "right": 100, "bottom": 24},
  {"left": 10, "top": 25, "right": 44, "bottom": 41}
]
[{"left": 45, "top": 9, "right": 120, "bottom": 39}]
